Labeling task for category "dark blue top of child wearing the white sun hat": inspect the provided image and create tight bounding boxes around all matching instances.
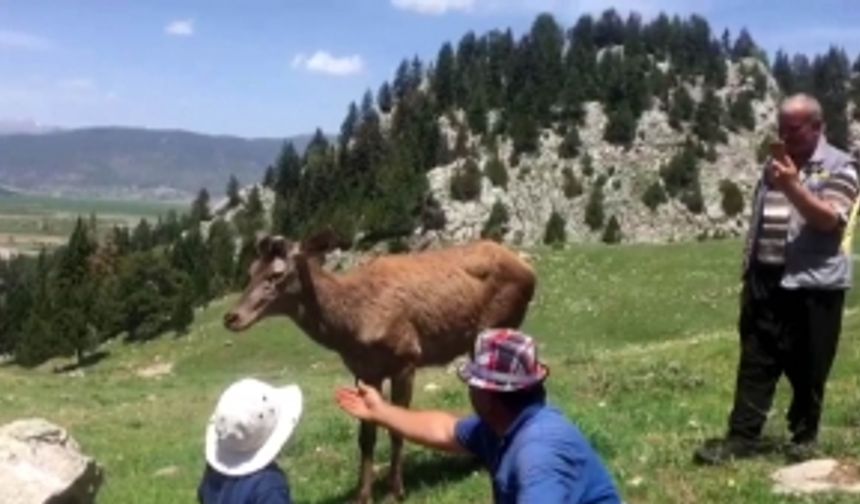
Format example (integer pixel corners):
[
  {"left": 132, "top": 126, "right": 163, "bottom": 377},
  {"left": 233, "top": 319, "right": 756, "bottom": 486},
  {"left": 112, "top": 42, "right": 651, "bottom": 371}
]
[{"left": 197, "top": 463, "right": 293, "bottom": 504}]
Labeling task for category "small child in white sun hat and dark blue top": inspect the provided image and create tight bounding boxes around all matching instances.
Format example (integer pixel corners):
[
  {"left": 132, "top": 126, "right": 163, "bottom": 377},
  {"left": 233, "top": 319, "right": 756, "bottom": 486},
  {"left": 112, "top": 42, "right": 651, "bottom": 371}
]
[{"left": 197, "top": 378, "right": 302, "bottom": 504}]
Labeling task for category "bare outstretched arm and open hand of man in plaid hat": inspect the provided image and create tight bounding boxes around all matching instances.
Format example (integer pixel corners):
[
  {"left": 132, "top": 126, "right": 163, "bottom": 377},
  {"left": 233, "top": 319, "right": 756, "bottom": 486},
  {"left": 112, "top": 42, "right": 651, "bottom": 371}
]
[{"left": 335, "top": 382, "right": 466, "bottom": 453}]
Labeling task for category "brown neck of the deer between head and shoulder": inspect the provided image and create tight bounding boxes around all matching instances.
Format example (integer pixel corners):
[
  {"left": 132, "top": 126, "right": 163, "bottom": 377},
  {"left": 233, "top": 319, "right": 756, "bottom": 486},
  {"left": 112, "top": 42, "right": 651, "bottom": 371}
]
[{"left": 293, "top": 260, "right": 358, "bottom": 354}]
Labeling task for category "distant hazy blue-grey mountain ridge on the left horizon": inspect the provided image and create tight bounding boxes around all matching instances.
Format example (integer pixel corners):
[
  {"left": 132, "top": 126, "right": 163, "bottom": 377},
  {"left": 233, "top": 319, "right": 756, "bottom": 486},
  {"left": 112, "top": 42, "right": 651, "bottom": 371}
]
[{"left": 0, "top": 127, "right": 308, "bottom": 195}]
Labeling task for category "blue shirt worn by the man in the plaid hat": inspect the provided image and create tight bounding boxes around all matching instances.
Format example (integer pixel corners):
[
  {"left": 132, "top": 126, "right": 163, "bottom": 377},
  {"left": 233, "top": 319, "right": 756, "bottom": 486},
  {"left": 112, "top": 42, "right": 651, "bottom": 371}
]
[{"left": 456, "top": 403, "right": 621, "bottom": 504}]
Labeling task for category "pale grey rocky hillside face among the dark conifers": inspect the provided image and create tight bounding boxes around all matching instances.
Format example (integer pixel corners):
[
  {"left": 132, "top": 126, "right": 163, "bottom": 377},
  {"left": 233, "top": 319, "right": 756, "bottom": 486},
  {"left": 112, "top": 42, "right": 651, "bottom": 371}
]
[{"left": 416, "top": 59, "right": 860, "bottom": 245}]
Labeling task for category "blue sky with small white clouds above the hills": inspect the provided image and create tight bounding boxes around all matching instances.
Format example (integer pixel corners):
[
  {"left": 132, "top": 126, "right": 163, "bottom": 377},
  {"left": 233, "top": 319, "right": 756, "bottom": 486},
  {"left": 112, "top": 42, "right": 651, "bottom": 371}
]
[{"left": 0, "top": 0, "right": 860, "bottom": 137}]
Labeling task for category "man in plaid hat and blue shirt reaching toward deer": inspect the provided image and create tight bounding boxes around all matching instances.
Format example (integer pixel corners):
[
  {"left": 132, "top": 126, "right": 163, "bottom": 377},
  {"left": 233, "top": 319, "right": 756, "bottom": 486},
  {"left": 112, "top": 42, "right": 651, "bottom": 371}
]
[{"left": 336, "top": 329, "right": 621, "bottom": 504}]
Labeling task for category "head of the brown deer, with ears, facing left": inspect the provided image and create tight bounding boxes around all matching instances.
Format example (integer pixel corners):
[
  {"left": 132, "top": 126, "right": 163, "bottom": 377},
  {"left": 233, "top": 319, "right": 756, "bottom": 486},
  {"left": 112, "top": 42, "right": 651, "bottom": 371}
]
[{"left": 224, "top": 230, "right": 343, "bottom": 331}]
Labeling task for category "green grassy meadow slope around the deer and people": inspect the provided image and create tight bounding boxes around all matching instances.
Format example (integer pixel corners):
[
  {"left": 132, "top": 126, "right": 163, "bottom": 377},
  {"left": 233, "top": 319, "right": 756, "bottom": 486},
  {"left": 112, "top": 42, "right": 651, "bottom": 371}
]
[{"left": 0, "top": 241, "right": 860, "bottom": 504}]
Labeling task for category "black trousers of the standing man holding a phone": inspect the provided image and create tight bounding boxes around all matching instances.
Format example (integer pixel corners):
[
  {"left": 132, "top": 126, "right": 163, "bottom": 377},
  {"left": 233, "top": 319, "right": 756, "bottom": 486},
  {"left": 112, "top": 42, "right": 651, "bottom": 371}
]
[{"left": 729, "top": 263, "right": 845, "bottom": 443}]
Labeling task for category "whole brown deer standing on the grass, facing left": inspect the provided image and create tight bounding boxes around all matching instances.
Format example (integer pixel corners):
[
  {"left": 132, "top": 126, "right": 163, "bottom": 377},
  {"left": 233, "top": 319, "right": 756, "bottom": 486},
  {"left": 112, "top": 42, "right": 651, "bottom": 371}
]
[{"left": 224, "top": 233, "right": 535, "bottom": 503}]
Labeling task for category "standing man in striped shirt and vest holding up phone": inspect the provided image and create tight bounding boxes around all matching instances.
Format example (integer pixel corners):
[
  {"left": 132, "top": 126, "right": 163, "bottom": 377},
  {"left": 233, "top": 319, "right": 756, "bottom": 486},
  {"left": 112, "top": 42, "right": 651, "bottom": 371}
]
[{"left": 694, "top": 94, "right": 858, "bottom": 464}]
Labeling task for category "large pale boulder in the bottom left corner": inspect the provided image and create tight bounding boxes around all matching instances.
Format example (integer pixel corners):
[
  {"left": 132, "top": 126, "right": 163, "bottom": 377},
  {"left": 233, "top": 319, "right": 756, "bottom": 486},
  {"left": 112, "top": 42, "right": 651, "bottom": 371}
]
[{"left": 0, "top": 418, "right": 103, "bottom": 504}]
